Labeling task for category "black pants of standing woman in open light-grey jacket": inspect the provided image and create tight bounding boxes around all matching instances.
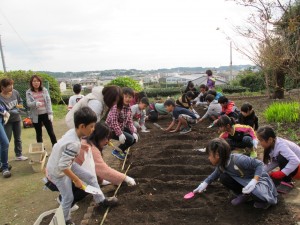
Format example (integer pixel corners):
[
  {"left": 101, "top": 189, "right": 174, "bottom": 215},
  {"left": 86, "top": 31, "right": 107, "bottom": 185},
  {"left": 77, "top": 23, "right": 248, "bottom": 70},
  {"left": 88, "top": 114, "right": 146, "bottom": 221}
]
[{"left": 33, "top": 114, "right": 57, "bottom": 146}]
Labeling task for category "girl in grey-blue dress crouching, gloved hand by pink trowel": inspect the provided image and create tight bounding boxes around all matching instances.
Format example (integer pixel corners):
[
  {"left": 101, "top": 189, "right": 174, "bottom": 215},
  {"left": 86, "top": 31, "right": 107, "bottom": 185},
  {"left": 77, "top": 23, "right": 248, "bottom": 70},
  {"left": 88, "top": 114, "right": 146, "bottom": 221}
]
[{"left": 193, "top": 138, "right": 277, "bottom": 209}]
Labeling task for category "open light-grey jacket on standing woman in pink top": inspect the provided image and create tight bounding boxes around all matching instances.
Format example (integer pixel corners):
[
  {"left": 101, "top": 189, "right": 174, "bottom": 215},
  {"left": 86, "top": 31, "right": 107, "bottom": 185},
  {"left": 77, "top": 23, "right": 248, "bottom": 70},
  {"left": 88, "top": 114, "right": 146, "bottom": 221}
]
[{"left": 26, "top": 88, "right": 53, "bottom": 123}]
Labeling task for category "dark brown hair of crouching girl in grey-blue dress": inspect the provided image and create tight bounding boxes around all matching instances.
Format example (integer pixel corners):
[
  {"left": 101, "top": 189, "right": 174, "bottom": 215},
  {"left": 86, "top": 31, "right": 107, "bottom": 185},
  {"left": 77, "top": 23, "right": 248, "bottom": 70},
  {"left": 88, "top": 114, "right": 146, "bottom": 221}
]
[{"left": 206, "top": 138, "right": 231, "bottom": 169}]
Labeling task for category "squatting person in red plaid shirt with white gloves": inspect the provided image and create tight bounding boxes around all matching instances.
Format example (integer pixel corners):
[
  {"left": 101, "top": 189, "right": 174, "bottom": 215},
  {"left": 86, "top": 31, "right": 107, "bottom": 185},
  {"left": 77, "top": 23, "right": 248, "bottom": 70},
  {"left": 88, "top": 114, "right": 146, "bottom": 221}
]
[{"left": 106, "top": 87, "right": 138, "bottom": 160}]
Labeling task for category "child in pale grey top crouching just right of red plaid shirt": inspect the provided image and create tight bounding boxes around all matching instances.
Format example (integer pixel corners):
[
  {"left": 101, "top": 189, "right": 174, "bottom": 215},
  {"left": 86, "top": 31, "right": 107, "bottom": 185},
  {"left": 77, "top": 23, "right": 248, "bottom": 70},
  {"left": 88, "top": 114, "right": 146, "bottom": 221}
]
[{"left": 130, "top": 97, "right": 149, "bottom": 132}]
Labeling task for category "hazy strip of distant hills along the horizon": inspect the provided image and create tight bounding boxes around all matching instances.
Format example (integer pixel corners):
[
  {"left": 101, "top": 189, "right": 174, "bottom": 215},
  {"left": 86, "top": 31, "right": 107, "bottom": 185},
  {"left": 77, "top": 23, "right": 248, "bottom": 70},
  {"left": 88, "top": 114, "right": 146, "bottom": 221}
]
[{"left": 39, "top": 65, "right": 253, "bottom": 78}]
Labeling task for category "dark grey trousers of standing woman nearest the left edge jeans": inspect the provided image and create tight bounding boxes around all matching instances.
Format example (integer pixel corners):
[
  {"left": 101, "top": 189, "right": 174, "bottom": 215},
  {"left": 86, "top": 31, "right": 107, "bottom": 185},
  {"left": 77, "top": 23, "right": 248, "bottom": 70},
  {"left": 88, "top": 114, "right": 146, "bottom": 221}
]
[{"left": 4, "top": 120, "right": 22, "bottom": 157}]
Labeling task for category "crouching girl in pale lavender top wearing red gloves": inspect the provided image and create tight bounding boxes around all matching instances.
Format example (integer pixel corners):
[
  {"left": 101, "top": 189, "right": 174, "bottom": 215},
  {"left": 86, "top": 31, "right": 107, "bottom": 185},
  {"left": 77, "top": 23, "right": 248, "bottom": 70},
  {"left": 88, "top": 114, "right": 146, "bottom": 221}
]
[{"left": 257, "top": 126, "right": 300, "bottom": 184}]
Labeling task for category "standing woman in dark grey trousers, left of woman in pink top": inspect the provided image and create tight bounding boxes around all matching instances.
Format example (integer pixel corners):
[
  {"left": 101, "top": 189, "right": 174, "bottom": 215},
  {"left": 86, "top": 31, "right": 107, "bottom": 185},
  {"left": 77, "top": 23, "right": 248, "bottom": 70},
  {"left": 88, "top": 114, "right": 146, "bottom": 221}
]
[{"left": 0, "top": 78, "right": 28, "bottom": 161}]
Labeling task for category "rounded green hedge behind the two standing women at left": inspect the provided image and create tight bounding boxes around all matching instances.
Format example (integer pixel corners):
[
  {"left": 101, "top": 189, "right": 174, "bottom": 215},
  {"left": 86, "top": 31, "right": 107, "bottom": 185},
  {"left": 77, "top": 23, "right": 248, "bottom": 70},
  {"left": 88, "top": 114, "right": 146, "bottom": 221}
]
[{"left": 0, "top": 70, "right": 61, "bottom": 104}]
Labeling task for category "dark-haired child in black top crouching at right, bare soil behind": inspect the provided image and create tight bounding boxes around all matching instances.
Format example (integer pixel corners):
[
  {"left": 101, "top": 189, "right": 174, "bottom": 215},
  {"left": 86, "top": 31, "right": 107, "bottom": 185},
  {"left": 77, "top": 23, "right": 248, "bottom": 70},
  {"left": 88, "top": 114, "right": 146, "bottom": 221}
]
[{"left": 238, "top": 102, "right": 258, "bottom": 130}]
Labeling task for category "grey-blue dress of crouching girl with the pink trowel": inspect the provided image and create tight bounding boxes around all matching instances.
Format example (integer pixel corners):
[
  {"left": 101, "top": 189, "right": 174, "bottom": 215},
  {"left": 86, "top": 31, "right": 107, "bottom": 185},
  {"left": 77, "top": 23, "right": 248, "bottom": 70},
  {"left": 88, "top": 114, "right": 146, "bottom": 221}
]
[{"left": 204, "top": 154, "right": 278, "bottom": 205}]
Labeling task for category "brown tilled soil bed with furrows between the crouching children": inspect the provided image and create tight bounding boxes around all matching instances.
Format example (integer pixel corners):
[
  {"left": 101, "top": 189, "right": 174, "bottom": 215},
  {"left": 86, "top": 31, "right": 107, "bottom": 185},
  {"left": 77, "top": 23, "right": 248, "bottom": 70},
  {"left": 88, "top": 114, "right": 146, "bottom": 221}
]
[{"left": 89, "top": 103, "right": 294, "bottom": 225}]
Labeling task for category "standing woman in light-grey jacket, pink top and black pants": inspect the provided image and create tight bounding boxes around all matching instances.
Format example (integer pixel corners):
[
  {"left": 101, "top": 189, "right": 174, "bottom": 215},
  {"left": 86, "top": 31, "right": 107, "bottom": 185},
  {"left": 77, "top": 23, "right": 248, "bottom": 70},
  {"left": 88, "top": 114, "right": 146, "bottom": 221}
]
[{"left": 26, "top": 75, "right": 57, "bottom": 145}]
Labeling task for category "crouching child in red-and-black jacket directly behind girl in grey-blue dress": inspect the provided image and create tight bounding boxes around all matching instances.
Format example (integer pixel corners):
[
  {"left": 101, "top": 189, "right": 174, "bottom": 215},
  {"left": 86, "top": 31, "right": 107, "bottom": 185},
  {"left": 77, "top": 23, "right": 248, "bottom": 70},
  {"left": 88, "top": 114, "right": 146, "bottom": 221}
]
[{"left": 216, "top": 115, "right": 258, "bottom": 158}]
